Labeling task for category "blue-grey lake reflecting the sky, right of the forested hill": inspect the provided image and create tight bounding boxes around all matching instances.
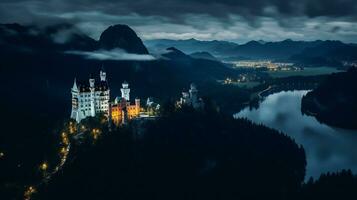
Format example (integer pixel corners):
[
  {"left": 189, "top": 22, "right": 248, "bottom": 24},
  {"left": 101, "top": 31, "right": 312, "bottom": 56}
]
[{"left": 234, "top": 90, "right": 357, "bottom": 180}]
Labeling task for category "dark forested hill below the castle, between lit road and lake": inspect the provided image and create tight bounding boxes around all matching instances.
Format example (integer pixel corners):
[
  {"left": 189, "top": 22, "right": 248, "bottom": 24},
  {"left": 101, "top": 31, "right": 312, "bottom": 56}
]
[{"left": 34, "top": 106, "right": 306, "bottom": 200}]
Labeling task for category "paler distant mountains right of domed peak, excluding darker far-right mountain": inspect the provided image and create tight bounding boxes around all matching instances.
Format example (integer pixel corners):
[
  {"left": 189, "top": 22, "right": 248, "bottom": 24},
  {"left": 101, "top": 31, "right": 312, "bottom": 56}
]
[{"left": 145, "top": 39, "right": 318, "bottom": 59}]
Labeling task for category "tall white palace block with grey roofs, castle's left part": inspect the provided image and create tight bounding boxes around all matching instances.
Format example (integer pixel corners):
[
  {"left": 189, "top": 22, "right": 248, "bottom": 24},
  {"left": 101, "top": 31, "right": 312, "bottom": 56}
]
[{"left": 71, "top": 70, "right": 110, "bottom": 122}]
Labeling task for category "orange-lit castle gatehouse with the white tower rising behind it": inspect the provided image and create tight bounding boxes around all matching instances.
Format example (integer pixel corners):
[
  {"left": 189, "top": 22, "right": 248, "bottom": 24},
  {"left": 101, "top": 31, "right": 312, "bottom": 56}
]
[{"left": 111, "top": 82, "right": 141, "bottom": 126}]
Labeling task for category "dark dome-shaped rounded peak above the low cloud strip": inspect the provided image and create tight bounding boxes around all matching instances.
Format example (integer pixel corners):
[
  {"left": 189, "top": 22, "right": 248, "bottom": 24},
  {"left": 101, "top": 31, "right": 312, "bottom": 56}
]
[{"left": 99, "top": 24, "right": 149, "bottom": 54}]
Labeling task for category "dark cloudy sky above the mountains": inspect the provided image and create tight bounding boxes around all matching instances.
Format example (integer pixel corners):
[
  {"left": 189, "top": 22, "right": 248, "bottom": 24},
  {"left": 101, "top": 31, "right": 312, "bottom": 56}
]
[{"left": 0, "top": 0, "right": 357, "bottom": 43}]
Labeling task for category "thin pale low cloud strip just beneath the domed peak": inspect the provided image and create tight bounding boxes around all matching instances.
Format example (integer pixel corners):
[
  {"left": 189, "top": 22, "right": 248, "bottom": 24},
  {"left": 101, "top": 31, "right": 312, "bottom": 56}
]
[{"left": 65, "top": 49, "right": 156, "bottom": 61}]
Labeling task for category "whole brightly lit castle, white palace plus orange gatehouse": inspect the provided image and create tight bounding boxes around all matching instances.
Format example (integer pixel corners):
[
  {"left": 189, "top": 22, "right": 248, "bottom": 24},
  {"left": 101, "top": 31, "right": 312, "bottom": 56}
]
[{"left": 71, "top": 69, "right": 141, "bottom": 126}]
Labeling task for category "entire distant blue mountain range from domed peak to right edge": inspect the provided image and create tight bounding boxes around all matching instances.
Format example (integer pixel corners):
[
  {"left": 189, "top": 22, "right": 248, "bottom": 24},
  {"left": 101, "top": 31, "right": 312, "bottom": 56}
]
[{"left": 145, "top": 39, "right": 357, "bottom": 66}]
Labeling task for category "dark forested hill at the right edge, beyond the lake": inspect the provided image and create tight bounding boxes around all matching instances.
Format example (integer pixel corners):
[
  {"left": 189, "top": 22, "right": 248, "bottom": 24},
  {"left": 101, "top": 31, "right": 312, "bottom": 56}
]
[{"left": 302, "top": 68, "right": 357, "bottom": 129}]
